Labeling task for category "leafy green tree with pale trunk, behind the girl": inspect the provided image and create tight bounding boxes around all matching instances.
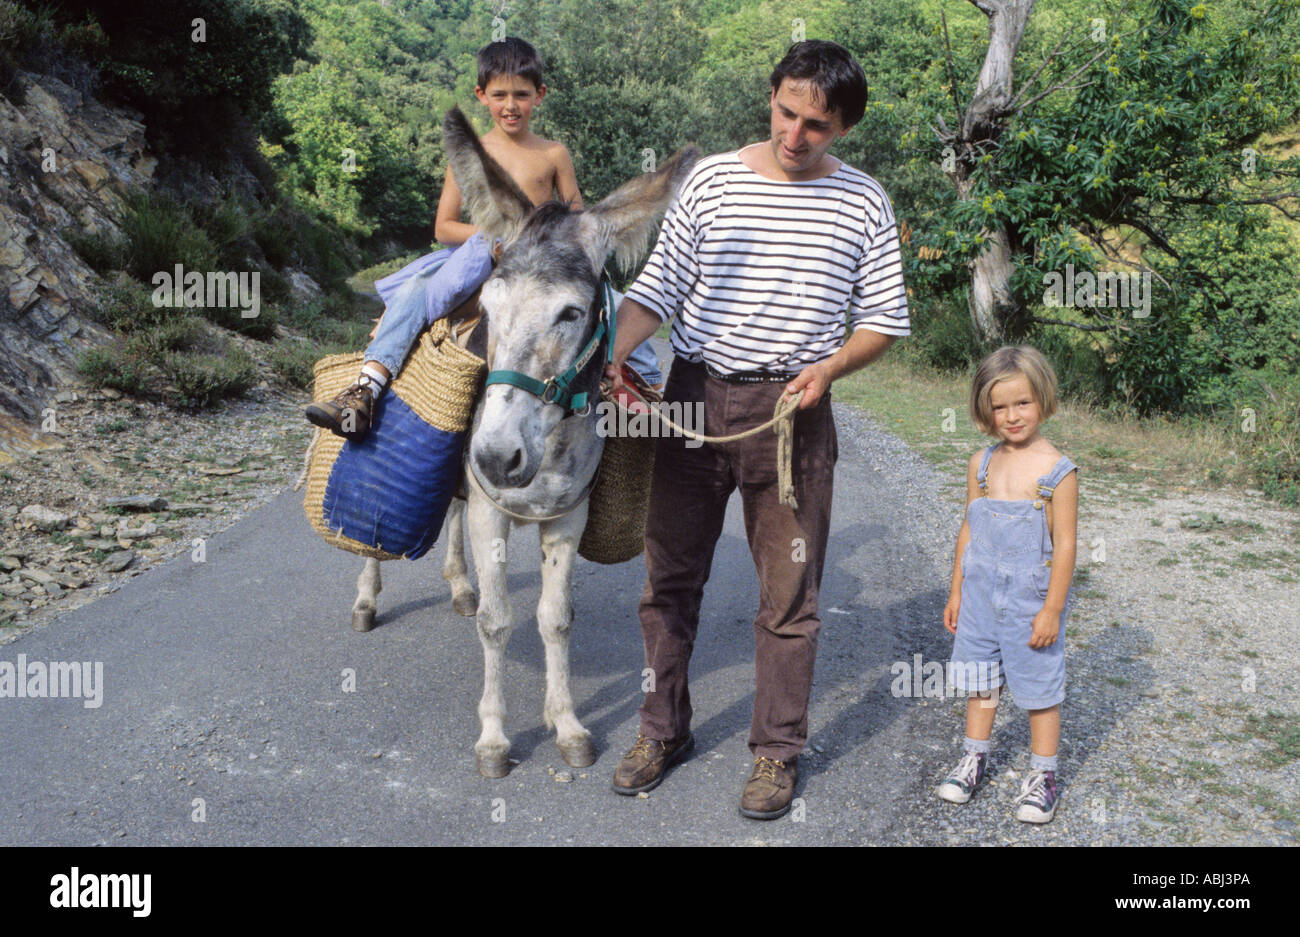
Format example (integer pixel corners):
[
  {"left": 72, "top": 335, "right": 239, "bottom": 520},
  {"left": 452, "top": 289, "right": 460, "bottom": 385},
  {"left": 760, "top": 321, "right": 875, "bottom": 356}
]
[{"left": 918, "top": 0, "right": 1300, "bottom": 361}]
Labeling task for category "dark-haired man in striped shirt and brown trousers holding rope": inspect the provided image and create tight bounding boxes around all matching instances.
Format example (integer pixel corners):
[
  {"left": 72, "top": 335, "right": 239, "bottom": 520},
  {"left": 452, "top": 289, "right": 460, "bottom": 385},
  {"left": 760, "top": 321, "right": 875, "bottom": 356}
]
[{"left": 610, "top": 40, "right": 910, "bottom": 820}]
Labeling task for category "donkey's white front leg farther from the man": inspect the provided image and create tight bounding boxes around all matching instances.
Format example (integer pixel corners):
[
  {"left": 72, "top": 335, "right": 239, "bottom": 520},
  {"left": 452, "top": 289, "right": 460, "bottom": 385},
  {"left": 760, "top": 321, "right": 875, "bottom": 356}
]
[{"left": 467, "top": 491, "right": 511, "bottom": 777}]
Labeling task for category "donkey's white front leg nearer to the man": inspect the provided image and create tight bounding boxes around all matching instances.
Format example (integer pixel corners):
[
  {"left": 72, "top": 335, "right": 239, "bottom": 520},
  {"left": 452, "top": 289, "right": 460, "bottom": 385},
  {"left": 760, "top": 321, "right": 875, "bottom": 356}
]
[{"left": 537, "top": 504, "right": 595, "bottom": 768}]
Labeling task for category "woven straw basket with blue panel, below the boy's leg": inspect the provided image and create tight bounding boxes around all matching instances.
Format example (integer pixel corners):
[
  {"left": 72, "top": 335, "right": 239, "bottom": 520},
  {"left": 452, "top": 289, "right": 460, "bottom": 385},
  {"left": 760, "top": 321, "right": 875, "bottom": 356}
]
[{"left": 303, "top": 320, "right": 486, "bottom": 560}]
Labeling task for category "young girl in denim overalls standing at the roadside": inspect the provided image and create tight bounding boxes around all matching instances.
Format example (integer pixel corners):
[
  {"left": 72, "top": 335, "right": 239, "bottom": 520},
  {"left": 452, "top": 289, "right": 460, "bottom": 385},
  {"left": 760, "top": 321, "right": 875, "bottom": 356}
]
[{"left": 939, "top": 346, "right": 1079, "bottom": 823}]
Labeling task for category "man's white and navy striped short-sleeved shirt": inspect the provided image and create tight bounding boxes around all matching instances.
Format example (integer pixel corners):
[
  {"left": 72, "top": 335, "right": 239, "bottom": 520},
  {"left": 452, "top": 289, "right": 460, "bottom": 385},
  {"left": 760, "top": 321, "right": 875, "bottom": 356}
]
[{"left": 627, "top": 144, "right": 911, "bottom": 374}]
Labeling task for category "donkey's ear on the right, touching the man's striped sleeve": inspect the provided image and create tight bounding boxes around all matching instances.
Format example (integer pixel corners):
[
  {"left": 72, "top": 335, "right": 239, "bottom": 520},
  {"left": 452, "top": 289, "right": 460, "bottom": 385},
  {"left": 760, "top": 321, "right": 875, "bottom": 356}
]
[{"left": 581, "top": 147, "right": 699, "bottom": 272}]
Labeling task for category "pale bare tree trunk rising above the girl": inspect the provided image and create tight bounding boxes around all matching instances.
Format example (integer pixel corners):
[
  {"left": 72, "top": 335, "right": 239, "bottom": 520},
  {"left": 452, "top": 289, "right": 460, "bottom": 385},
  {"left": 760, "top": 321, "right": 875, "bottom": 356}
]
[{"left": 949, "top": 0, "right": 1034, "bottom": 342}]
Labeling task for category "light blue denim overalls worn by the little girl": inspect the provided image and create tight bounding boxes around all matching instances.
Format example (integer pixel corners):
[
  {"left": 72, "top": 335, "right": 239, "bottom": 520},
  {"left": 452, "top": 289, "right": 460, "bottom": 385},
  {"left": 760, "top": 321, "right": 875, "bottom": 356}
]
[{"left": 949, "top": 443, "right": 1078, "bottom": 710}]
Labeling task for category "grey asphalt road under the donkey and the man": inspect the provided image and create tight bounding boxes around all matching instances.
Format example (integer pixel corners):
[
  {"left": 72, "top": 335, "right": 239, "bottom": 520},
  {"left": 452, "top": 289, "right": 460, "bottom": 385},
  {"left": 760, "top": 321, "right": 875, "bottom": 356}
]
[{"left": 0, "top": 405, "right": 958, "bottom": 845}]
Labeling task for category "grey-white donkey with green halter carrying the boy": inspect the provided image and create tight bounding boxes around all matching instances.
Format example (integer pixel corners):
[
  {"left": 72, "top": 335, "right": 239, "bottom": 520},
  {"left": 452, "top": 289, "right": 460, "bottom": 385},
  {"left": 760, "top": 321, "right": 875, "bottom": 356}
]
[{"left": 354, "top": 108, "right": 698, "bottom": 777}]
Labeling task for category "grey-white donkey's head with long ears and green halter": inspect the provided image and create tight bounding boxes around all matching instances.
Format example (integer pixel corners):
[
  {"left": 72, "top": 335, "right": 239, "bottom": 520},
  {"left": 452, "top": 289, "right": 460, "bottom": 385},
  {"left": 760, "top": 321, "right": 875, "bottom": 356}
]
[{"left": 442, "top": 109, "right": 698, "bottom": 489}]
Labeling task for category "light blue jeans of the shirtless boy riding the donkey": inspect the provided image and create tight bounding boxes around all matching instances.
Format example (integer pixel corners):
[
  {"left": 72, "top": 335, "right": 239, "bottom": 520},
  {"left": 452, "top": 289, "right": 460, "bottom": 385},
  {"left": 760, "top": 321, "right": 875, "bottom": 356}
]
[{"left": 364, "top": 234, "right": 663, "bottom": 383}]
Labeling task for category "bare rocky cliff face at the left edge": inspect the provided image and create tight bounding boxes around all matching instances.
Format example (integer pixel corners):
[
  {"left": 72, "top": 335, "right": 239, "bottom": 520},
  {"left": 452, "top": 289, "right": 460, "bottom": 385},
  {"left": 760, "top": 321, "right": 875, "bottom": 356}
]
[{"left": 0, "top": 74, "right": 157, "bottom": 431}]
